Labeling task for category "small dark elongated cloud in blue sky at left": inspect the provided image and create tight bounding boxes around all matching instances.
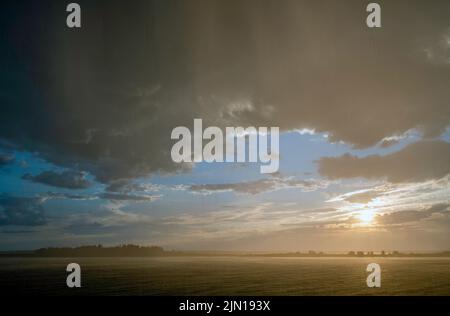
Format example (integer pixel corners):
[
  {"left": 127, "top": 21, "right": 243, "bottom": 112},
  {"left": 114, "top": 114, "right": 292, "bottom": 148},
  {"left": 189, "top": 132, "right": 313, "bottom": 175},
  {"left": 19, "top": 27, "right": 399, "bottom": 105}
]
[{"left": 22, "top": 171, "right": 91, "bottom": 189}]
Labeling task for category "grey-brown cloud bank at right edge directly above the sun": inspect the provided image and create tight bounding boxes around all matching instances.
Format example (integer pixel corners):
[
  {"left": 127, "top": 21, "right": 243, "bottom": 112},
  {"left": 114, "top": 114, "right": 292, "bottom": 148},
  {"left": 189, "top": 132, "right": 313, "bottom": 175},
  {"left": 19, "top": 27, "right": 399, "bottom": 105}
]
[{"left": 319, "top": 141, "right": 450, "bottom": 182}]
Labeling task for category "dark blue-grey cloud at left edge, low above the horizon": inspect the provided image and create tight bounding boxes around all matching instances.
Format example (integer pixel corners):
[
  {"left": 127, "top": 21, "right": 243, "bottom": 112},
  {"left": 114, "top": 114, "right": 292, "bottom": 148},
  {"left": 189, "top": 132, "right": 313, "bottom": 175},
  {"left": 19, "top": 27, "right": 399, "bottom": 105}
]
[{"left": 0, "top": 195, "right": 47, "bottom": 226}]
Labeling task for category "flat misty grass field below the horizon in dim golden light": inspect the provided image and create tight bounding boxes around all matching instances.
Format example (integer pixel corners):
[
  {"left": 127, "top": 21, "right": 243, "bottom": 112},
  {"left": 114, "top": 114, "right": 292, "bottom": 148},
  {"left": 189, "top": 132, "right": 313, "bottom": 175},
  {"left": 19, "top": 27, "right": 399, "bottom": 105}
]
[{"left": 0, "top": 257, "right": 450, "bottom": 296}]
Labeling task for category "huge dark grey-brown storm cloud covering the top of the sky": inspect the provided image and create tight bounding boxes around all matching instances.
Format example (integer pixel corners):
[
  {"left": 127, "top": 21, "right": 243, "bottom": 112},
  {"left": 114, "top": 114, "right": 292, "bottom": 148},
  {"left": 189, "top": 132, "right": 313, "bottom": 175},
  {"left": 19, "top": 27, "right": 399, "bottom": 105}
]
[{"left": 0, "top": 0, "right": 450, "bottom": 182}]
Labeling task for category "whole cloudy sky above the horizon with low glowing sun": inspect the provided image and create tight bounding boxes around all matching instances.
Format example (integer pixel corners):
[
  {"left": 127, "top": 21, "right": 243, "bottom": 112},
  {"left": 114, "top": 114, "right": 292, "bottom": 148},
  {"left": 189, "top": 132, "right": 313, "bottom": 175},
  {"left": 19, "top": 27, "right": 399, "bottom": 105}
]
[{"left": 0, "top": 0, "right": 450, "bottom": 251}]
